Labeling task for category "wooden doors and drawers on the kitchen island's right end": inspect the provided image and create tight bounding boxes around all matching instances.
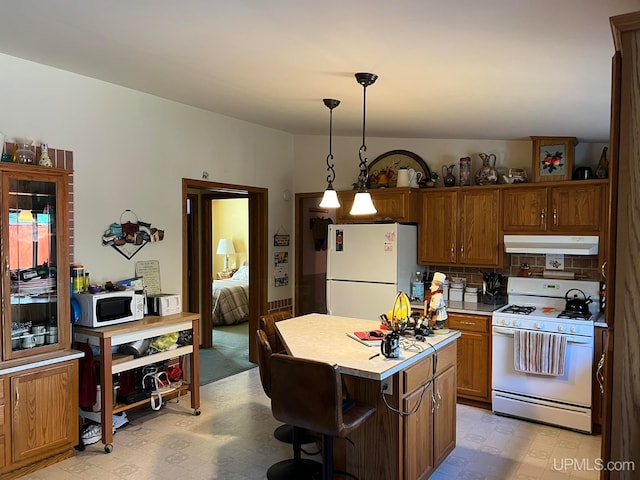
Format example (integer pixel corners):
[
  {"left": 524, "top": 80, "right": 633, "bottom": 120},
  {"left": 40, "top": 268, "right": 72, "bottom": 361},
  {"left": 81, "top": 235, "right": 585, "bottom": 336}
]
[{"left": 402, "top": 344, "right": 456, "bottom": 480}]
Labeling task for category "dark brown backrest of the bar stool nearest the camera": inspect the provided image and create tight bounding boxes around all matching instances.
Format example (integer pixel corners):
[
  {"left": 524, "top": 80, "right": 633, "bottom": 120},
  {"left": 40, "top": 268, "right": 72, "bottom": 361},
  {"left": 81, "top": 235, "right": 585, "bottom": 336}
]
[{"left": 271, "top": 353, "right": 344, "bottom": 436}]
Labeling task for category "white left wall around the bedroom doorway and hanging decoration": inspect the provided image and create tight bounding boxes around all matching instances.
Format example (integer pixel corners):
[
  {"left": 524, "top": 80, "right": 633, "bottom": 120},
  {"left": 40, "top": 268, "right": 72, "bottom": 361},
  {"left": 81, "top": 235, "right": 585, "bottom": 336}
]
[{"left": 0, "top": 54, "right": 293, "bottom": 300}]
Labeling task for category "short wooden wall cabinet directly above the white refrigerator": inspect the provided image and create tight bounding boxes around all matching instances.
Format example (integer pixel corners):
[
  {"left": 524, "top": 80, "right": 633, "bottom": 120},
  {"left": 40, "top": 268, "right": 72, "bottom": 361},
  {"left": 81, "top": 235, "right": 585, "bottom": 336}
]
[{"left": 336, "top": 187, "right": 420, "bottom": 223}]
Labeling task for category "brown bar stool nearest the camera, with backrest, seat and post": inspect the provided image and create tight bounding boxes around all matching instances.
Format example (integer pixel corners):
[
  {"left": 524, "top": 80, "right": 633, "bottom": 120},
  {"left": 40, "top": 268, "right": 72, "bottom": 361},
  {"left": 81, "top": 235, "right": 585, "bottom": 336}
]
[{"left": 271, "top": 354, "right": 376, "bottom": 480}]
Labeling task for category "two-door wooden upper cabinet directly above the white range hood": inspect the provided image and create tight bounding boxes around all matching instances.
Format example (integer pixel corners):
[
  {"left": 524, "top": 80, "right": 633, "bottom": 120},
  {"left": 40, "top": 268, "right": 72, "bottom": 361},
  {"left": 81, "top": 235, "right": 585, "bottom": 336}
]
[{"left": 501, "top": 180, "right": 607, "bottom": 235}]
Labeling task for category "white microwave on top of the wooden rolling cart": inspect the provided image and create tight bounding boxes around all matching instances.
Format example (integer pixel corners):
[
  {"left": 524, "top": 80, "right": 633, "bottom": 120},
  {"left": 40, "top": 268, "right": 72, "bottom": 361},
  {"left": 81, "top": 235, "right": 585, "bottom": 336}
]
[{"left": 74, "top": 290, "right": 144, "bottom": 328}]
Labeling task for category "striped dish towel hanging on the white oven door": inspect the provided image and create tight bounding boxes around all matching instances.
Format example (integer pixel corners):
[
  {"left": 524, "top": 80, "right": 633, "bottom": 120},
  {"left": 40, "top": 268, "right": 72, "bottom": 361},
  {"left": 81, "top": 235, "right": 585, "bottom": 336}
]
[{"left": 513, "top": 330, "right": 567, "bottom": 377}]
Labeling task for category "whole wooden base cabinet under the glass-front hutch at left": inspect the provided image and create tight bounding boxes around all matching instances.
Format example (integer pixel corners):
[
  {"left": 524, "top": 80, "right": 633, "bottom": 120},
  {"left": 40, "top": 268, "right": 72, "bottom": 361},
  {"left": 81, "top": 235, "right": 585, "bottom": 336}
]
[{"left": 0, "top": 360, "right": 78, "bottom": 478}]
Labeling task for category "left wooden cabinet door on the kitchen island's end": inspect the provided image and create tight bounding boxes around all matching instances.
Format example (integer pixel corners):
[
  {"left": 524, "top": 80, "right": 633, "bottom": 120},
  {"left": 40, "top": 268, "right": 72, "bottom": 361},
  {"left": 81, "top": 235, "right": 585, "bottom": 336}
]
[{"left": 402, "top": 385, "right": 438, "bottom": 480}]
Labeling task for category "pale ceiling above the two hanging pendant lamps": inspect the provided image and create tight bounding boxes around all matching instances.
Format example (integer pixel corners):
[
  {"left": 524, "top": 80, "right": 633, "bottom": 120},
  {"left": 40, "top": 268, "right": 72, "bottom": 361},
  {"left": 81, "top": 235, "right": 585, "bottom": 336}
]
[{"left": 0, "top": 0, "right": 640, "bottom": 142}]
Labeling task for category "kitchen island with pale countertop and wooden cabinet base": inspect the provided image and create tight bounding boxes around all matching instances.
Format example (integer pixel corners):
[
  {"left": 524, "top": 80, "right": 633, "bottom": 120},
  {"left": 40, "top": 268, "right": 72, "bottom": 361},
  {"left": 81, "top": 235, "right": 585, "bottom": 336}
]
[{"left": 276, "top": 314, "right": 460, "bottom": 480}]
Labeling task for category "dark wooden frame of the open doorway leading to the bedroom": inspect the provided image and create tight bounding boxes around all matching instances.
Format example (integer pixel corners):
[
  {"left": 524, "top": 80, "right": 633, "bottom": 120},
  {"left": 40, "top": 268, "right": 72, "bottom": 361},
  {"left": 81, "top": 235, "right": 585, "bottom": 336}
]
[{"left": 182, "top": 178, "right": 268, "bottom": 363}]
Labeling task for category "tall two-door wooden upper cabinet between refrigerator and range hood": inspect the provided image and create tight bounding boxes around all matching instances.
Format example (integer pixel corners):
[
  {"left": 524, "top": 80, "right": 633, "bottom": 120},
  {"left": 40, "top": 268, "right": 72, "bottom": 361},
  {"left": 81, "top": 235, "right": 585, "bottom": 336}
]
[{"left": 418, "top": 187, "right": 502, "bottom": 267}]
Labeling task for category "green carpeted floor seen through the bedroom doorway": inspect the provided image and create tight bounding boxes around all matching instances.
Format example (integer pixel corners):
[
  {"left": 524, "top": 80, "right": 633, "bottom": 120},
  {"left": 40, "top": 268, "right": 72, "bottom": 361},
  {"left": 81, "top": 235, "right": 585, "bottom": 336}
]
[{"left": 200, "top": 322, "right": 257, "bottom": 385}]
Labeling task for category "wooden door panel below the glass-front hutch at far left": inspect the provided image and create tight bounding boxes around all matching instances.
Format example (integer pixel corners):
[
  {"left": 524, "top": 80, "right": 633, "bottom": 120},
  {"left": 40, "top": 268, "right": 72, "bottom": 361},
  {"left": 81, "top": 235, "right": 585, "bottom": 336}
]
[{"left": 11, "top": 361, "right": 78, "bottom": 463}]
